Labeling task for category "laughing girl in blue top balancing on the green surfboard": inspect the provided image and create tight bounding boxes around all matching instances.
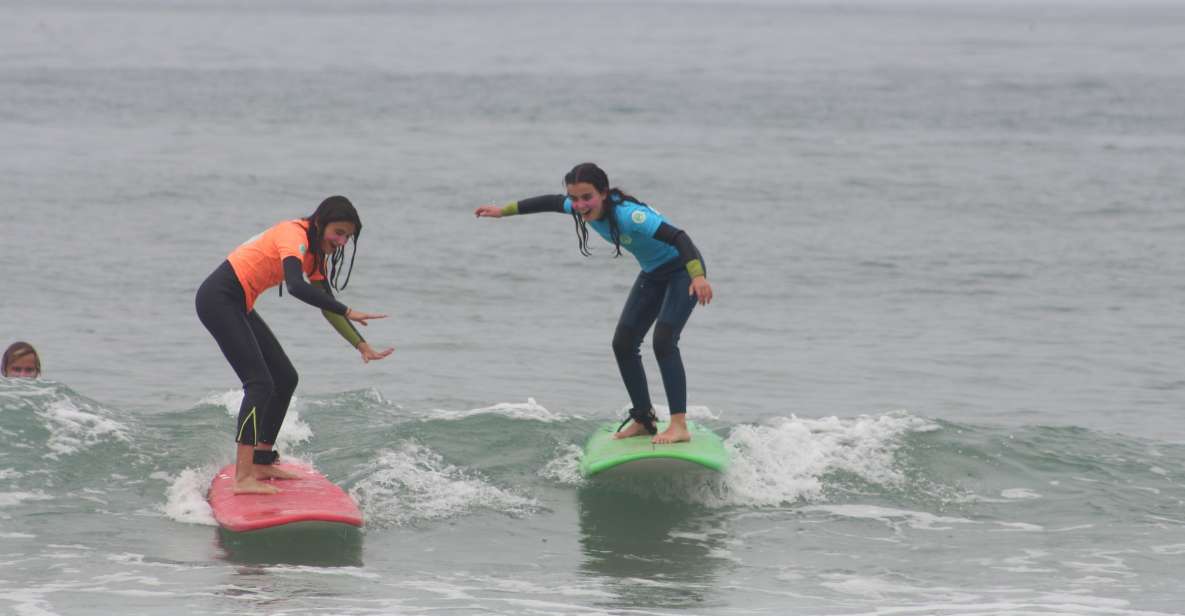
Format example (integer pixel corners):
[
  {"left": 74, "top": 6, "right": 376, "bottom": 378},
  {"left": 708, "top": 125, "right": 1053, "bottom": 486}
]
[{"left": 474, "top": 162, "right": 712, "bottom": 443}]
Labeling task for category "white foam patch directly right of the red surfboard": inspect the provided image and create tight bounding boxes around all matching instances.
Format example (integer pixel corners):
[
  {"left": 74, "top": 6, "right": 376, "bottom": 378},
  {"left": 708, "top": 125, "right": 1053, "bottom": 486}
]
[{"left": 350, "top": 441, "right": 539, "bottom": 525}]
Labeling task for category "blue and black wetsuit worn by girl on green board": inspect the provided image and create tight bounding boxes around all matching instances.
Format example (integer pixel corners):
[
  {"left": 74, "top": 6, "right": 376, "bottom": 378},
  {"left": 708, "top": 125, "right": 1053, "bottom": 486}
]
[{"left": 502, "top": 193, "right": 705, "bottom": 415}]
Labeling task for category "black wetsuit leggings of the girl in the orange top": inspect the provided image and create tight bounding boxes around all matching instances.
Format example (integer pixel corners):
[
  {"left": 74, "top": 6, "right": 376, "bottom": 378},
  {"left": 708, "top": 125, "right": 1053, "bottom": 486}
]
[{"left": 194, "top": 261, "right": 297, "bottom": 445}]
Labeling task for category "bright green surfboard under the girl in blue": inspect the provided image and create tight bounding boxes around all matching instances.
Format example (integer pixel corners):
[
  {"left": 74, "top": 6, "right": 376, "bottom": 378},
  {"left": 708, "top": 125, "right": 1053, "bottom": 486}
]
[{"left": 581, "top": 421, "right": 729, "bottom": 477}]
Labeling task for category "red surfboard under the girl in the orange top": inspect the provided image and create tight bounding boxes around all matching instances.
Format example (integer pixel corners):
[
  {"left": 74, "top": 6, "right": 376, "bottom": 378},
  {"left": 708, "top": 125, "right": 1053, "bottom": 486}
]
[{"left": 209, "top": 462, "right": 363, "bottom": 532}]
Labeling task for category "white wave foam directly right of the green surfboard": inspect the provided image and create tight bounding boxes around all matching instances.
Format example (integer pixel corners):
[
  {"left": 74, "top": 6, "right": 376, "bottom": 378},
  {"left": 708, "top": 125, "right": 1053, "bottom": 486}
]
[{"left": 710, "top": 411, "right": 935, "bottom": 506}]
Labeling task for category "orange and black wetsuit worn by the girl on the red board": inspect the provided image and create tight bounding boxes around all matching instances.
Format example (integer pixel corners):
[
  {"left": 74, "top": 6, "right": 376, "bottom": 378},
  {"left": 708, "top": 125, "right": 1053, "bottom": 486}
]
[{"left": 194, "top": 219, "right": 363, "bottom": 445}]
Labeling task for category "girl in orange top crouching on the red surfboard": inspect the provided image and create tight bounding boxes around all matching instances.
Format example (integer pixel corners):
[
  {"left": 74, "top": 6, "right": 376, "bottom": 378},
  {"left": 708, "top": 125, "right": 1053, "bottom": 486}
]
[{"left": 194, "top": 197, "right": 395, "bottom": 494}]
